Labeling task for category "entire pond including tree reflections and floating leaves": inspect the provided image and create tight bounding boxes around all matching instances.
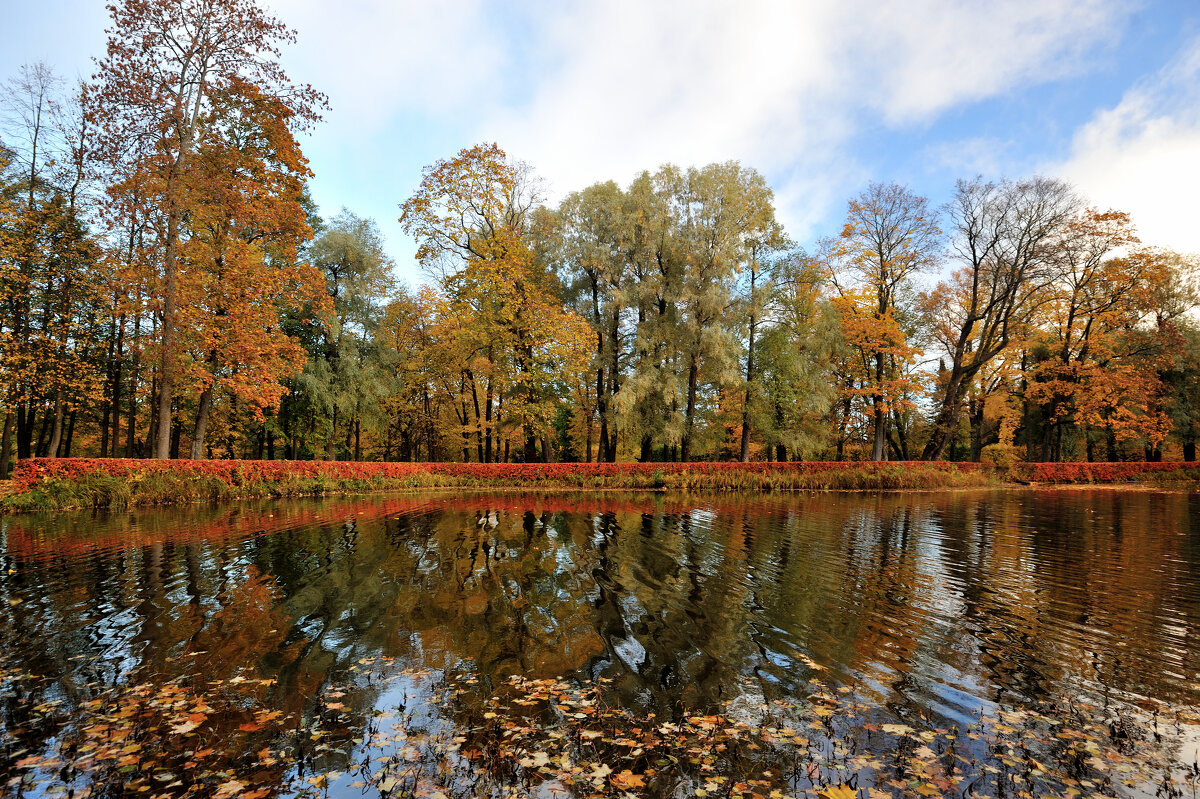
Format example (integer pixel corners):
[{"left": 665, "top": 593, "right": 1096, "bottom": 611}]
[{"left": 0, "top": 489, "right": 1200, "bottom": 799}]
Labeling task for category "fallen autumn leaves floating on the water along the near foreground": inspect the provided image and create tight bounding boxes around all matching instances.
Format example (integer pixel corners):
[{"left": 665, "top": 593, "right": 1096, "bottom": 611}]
[{"left": 0, "top": 657, "right": 1200, "bottom": 799}]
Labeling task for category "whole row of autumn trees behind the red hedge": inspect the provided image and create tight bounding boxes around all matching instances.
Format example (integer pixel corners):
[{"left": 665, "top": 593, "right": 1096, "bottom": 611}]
[{"left": 0, "top": 0, "right": 1200, "bottom": 467}]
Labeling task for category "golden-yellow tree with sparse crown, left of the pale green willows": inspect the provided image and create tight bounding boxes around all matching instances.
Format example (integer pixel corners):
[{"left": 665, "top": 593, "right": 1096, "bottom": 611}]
[{"left": 400, "top": 144, "right": 589, "bottom": 461}]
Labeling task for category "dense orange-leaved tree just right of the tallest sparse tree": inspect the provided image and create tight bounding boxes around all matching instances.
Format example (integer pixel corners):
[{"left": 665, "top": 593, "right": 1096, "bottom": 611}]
[{"left": 169, "top": 83, "right": 329, "bottom": 459}]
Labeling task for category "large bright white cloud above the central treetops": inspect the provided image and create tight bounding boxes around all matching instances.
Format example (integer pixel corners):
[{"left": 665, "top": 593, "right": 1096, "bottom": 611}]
[{"left": 465, "top": 0, "right": 1127, "bottom": 244}]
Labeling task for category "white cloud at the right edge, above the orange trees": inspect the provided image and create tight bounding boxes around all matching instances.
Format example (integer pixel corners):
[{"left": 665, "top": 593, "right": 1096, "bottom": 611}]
[{"left": 1054, "top": 40, "right": 1200, "bottom": 253}]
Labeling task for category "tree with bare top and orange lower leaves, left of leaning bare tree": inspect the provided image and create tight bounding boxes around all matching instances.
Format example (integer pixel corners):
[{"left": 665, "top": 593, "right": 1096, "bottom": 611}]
[{"left": 823, "top": 177, "right": 942, "bottom": 461}]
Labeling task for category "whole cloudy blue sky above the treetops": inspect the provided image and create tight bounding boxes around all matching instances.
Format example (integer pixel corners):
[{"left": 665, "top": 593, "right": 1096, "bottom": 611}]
[{"left": 0, "top": 0, "right": 1200, "bottom": 283}]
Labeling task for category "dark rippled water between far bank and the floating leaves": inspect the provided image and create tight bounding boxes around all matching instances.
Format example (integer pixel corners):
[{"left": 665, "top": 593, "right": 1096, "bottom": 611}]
[{"left": 0, "top": 491, "right": 1200, "bottom": 795}]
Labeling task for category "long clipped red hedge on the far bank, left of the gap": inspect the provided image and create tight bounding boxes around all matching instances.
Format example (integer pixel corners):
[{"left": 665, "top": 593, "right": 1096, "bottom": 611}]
[{"left": 12, "top": 458, "right": 979, "bottom": 489}]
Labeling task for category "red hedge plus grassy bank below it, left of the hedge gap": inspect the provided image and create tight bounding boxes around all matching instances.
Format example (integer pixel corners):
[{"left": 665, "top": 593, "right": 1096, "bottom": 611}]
[{"left": 0, "top": 458, "right": 998, "bottom": 510}]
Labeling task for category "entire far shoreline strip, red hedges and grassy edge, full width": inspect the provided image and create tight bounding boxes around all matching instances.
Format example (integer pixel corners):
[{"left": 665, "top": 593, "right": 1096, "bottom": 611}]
[{"left": 0, "top": 458, "right": 1200, "bottom": 513}]
